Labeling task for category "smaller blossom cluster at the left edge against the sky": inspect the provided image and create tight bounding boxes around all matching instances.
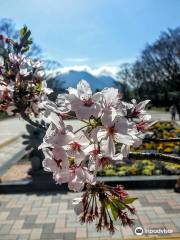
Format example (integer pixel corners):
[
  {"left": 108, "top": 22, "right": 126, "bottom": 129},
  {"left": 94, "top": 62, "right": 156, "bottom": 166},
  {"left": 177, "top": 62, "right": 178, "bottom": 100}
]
[{"left": 0, "top": 35, "right": 51, "bottom": 116}]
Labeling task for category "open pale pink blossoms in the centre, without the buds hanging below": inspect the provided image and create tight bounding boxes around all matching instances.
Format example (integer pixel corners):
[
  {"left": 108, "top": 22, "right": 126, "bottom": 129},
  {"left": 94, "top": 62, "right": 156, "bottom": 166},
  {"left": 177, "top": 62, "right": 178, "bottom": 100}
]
[{"left": 41, "top": 80, "right": 150, "bottom": 191}]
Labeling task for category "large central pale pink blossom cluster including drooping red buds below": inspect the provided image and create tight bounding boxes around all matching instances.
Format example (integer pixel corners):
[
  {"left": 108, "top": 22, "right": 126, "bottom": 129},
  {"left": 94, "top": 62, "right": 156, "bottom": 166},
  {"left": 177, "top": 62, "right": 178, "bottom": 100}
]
[{"left": 40, "top": 80, "right": 150, "bottom": 232}]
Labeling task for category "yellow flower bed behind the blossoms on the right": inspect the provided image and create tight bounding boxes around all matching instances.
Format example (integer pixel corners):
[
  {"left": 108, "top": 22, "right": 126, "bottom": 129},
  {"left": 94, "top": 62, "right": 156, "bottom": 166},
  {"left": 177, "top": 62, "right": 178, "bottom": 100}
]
[{"left": 99, "top": 122, "right": 180, "bottom": 176}]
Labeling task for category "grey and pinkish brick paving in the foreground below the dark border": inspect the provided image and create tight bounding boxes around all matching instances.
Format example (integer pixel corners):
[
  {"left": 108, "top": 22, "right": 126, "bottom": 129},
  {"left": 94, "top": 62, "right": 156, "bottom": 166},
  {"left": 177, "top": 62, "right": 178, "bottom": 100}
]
[{"left": 0, "top": 190, "right": 180, "bottom": 240}]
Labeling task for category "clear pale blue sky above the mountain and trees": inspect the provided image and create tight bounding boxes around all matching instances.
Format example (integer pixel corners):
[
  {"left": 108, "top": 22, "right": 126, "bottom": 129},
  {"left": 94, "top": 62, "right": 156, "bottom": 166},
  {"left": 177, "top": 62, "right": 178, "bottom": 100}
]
[{"left": 0, "top": 0, "right": 180, "bottom": 67}]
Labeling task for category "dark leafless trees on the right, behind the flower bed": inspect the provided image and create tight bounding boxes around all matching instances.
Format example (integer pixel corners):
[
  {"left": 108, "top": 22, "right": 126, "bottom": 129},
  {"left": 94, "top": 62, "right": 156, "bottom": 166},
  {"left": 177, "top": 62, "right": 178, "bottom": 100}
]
[{"left": 116, "top": 27, "right": 180, "bottom": 106}]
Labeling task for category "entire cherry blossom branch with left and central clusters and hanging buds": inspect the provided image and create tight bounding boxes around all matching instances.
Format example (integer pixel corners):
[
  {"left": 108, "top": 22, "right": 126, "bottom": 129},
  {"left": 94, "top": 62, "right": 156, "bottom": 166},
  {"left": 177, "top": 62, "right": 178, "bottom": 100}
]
[{"left": 0, "top": 27, "right": 152, "bottom": 233}]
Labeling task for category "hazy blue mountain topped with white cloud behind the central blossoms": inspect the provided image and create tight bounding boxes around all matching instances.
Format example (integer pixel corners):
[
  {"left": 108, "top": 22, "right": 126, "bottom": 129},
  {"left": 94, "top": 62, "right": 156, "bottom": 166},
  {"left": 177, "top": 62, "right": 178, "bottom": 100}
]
[{"left": 46, "top": 69, "right": 122, "bottom": 91}]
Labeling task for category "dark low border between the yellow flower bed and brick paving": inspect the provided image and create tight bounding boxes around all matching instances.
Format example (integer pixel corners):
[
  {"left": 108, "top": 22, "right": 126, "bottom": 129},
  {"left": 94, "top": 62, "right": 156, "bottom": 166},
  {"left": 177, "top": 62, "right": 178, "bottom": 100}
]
[{"left": 0, "top": 173, "right": 178, "bottom": 193}]
